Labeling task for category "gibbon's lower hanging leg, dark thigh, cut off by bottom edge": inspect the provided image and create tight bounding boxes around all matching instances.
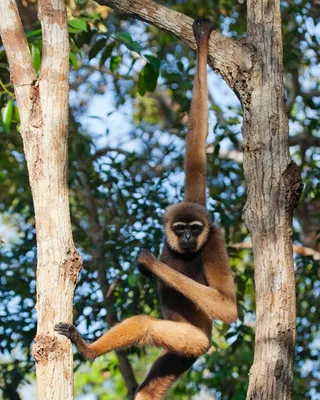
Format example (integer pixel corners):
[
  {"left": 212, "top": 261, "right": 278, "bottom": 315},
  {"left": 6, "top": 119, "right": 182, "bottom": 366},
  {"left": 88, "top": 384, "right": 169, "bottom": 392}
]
[{"left": 135, "top": 352, "right": 196, "bottom": 400}]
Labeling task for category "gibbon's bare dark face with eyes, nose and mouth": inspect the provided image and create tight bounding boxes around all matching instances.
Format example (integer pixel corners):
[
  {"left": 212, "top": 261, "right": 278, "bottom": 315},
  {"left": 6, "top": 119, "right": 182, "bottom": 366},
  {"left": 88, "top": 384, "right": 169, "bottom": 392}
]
[{"left": 172, "top": 221, "right": 203, "bottom": 252}]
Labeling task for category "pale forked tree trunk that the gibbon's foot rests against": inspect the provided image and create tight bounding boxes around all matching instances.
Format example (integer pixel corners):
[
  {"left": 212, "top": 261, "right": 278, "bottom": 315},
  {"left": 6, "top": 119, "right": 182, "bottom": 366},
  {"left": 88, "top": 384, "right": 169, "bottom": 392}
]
[{"left": 0, "top": 0, "right": 81, "bottom": 400}]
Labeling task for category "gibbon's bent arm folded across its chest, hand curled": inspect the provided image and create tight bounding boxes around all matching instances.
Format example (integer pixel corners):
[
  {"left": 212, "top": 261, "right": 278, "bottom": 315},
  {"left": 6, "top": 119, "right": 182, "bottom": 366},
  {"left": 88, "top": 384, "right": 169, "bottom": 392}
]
[{"left": 137, "top": 250, "right": 237, "bottom": 323}]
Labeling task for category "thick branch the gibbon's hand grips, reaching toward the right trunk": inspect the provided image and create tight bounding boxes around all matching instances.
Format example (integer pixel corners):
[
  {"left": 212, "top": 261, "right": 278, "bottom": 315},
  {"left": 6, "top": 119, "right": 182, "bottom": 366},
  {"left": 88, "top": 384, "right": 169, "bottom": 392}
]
[{"left": 96, "top": 0, "right": 253, "bottom": 88}]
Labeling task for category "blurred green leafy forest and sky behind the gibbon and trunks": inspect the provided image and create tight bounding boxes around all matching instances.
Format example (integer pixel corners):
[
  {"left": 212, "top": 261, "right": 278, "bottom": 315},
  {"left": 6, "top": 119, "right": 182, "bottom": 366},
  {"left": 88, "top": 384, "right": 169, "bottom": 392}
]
[{"left": 0, "top": 0, "right": 320, "bottom": 400}]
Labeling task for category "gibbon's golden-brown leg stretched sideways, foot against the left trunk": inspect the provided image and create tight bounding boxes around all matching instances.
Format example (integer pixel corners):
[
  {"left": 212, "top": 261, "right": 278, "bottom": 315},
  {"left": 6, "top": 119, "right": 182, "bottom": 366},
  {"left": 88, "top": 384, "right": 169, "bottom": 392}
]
[{"left": 54, "top": 315, "right": 210, "bottom": 360}]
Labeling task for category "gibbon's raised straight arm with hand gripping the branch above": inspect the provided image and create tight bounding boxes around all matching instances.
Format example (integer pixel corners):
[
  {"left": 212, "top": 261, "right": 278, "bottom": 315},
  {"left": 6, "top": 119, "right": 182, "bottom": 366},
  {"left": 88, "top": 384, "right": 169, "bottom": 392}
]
[{"left": 184, "top": 19, "right": 213, "bottom": 205}]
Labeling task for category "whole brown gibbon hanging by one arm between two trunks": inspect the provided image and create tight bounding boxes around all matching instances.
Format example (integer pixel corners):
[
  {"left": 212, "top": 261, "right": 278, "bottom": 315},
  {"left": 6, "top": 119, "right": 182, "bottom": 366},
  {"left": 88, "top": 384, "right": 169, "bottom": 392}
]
[{"left": 55, "top": 19, "right": 237, "bottom": 400}]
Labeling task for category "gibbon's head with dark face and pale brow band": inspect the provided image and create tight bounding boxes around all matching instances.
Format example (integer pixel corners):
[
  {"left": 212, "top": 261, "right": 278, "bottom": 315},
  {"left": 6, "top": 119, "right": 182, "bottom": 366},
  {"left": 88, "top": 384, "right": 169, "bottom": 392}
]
[{"left": 164, "top": 202, "right": 210, "bottom": 254}]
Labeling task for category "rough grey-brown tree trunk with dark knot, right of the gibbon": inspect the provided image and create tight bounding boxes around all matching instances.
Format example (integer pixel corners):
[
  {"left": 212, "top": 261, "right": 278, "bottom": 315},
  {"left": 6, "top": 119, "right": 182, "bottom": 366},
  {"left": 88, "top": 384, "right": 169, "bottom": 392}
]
[{"left": 242, "top": 0, "right": 302, "bottom": 400}]
